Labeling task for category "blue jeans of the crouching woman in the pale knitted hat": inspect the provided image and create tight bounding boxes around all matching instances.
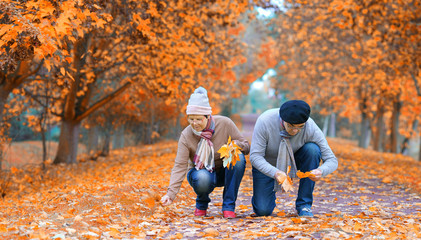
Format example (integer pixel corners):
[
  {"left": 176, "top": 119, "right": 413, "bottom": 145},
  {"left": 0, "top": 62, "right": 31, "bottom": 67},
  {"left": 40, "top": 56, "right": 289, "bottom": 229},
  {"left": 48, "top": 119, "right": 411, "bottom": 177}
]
[{"left": 187, "top": 154, "right": 246, "bottom": 211}]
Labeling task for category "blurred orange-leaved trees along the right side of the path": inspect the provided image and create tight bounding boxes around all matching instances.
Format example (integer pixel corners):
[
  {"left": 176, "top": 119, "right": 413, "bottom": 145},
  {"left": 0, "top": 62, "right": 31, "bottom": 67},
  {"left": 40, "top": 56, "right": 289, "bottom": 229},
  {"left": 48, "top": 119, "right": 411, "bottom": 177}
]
[{"left": 268, "top": 1, "right": 420, "bottom": 152}]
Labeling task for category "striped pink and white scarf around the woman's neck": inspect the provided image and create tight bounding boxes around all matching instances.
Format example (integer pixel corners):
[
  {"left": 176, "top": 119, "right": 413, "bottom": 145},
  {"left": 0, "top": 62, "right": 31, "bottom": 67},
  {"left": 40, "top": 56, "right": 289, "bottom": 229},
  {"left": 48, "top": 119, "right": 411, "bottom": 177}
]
[{"left": 192, "top": 116, "right": 215, "bottom": 172}]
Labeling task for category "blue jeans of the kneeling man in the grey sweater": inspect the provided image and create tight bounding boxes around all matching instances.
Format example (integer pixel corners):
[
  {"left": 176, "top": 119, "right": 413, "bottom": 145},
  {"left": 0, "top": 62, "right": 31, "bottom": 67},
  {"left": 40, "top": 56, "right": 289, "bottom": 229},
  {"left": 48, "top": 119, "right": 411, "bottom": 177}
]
[{"left": 251, "top": 142, "right": 322, "bottom": 216}]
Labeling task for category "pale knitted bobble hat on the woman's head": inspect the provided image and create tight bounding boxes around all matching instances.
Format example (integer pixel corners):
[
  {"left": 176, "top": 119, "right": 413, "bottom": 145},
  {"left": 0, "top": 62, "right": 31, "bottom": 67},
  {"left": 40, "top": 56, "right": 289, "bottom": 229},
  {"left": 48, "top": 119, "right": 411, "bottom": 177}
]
[{"left": 186, "top": 87, "right": 212, "bottom": 115}]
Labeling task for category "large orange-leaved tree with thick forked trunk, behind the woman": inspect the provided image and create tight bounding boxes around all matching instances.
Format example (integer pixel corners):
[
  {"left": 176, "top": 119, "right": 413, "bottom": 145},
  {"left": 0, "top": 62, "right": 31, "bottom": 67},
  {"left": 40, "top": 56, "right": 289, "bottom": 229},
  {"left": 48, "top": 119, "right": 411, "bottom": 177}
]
[{"left": 32, "top": 1, "right": 256, "bottom": 163}]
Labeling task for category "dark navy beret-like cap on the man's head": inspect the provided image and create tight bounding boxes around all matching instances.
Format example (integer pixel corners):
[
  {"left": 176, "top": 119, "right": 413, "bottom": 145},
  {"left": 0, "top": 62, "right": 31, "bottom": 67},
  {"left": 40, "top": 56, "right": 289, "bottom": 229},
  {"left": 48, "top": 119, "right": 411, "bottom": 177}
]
[{"left": 279, "top": 100, "right": 311, "bottom": 124}]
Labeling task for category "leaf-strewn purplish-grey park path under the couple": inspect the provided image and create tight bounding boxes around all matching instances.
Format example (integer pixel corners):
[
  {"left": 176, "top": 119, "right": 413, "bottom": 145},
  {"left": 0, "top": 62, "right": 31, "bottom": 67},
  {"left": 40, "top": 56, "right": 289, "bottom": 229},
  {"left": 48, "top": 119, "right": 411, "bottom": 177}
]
[{"left": 145, "top": 115, "right": 421, "bottom": 239}]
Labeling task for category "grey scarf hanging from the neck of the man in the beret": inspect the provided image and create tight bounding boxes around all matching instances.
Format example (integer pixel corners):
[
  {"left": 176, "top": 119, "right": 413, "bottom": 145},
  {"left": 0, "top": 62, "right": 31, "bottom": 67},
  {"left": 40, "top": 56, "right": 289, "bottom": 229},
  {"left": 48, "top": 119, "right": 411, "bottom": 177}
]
[{"left": 273, "top": 120, "right": 297, "bottom": 192}]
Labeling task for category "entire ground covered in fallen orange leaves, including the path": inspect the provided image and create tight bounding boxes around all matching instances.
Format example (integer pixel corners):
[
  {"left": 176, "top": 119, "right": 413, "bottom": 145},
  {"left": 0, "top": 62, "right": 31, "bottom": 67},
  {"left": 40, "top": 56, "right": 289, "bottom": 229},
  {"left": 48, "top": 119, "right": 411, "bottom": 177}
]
[{"left": 0, "top": 139, "right": 421, "bottom": 239}]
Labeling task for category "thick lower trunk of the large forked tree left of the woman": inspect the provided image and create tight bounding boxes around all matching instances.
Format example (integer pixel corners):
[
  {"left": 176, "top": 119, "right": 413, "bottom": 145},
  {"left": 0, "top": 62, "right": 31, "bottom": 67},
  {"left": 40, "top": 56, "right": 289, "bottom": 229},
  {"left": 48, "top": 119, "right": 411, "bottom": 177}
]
[{"left": 54, "top": 120, "right": 80, "bottom": 164}]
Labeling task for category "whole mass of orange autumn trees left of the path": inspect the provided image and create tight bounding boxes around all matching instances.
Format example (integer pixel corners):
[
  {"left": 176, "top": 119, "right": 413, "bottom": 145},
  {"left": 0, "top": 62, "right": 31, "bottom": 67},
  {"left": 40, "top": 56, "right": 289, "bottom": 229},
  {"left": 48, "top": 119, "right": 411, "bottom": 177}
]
[{"left": 0, "top": 0, "right": 265, "bottom": 169}]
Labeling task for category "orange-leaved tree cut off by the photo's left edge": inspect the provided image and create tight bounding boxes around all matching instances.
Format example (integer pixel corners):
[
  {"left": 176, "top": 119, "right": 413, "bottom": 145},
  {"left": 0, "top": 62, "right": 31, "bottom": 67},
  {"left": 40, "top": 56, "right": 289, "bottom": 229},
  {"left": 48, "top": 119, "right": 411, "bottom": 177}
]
[{"left": 0, "top": 0, "right": 95, "bottom": 168}]
